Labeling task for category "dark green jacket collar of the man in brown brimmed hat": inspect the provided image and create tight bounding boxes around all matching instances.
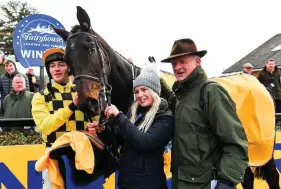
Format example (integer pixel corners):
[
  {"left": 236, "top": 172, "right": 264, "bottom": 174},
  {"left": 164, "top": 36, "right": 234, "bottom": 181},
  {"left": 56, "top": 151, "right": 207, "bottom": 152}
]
[{"left": 172, "top": 65, "right": 208, "bottom": 94}]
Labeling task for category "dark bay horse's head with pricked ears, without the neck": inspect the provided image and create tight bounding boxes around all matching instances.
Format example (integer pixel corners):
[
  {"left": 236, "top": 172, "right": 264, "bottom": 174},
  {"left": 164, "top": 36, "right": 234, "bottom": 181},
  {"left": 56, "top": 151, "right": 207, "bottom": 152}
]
[{"left": 53, "top": 6, "right": 110, "bottom": 116}]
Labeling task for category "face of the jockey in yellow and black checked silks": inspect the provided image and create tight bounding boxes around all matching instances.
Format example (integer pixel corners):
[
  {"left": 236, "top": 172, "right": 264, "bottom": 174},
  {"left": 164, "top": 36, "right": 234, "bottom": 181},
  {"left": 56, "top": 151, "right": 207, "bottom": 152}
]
[{"left": 49, "top": 61, "right": 69, "bottom": 83}]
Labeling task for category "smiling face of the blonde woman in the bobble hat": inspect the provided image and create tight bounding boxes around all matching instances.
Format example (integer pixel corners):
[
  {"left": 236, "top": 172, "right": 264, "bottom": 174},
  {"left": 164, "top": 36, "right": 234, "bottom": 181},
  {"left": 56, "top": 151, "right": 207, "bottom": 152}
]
[{"left": 135, "top": 86, "right": 153, "bottom": 107}]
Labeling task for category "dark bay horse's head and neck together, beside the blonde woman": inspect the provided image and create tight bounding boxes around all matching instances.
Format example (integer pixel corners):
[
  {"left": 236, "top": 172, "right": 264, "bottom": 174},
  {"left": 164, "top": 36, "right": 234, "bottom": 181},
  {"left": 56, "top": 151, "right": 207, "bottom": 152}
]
[{"left": 51, "top": 6, "right": 171, "bottom": 119}]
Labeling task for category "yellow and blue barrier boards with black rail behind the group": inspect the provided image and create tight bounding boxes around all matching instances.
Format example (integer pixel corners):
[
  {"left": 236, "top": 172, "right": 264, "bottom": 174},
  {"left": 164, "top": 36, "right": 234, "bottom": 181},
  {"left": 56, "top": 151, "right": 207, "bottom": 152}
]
[{"left": 0, "top": 114, "right": 281, "bottom": 189}]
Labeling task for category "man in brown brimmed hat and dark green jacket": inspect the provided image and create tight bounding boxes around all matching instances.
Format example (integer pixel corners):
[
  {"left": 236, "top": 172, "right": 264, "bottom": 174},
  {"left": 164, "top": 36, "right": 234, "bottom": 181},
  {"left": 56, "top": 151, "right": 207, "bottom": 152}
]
[{"left": 162, "top": 39, "right": 248, "bottom": 189}]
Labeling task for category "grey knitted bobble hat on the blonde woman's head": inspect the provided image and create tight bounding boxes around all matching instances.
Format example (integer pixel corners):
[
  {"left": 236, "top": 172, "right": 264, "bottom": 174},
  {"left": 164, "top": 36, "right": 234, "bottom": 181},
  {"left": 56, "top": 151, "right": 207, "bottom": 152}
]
[{"left": 133, "top": 64, "right": 161, "bottom": 96}]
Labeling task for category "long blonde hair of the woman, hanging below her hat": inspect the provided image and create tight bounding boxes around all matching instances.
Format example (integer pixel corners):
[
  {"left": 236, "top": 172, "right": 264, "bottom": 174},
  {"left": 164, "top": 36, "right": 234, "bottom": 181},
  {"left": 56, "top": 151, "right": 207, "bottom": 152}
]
[{"left": 130, "top": 88, "right": 161, "bottom": 133}]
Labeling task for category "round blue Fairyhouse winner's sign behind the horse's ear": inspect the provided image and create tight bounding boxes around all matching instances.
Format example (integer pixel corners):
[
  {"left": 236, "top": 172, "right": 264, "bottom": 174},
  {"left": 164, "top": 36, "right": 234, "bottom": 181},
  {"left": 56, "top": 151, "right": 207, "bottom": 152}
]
[{"left": 13, "top": 14, "right": 65, "bottom": 68}]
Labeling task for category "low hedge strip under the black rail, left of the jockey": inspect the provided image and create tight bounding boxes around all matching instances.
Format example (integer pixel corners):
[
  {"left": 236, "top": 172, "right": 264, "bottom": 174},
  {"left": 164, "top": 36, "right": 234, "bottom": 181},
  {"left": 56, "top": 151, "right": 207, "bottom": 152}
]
[{"left": 0, "top": 130, "right": 43, "bottom": 146}]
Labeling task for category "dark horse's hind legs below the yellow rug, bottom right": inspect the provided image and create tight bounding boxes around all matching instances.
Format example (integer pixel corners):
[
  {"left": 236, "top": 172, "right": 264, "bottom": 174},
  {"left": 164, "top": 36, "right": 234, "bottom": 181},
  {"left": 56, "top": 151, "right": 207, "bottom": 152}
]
[{"left": 242, "top": 158, "right": 280, "bottom": 189}]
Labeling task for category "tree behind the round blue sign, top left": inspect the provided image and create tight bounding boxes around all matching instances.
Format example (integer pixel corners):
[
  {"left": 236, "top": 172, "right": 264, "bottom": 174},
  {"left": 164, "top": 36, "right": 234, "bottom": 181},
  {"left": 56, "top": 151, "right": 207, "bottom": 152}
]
[{"left": 0, "top": 1, "right": 38, "bottom": 55}]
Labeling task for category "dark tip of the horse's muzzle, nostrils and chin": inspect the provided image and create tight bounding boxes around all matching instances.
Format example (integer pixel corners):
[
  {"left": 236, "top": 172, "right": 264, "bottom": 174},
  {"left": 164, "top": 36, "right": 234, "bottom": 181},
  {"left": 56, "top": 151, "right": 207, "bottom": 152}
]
[{"left": 78, "top": 97, "right": 101, "bottom": 117}]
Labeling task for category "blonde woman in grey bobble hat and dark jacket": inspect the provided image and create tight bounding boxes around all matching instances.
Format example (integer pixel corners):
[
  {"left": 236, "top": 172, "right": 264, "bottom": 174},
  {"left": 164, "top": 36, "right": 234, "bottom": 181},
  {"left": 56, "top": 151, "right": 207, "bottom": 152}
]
[{"left": 88, "top": 66, "right": 174, "bottom": 189}]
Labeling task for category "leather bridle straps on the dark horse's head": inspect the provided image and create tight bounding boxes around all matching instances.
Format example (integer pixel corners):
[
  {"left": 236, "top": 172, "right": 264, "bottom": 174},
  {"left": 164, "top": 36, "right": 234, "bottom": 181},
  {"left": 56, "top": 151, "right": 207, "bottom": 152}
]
[{"left": 66, "top": 32, "right": 112, "bottom": 126}]
